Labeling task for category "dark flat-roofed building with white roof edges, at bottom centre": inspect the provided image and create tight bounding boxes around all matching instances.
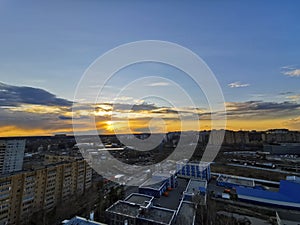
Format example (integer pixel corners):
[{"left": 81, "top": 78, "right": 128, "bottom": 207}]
[{"left": 106, "top": 193, "right": 196, "bottom": 225}]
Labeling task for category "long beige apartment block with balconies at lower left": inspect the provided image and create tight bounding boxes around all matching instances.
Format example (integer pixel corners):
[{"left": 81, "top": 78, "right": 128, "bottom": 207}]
[{"left": 0, "top": 160, "right": 92, "bottom": 225}]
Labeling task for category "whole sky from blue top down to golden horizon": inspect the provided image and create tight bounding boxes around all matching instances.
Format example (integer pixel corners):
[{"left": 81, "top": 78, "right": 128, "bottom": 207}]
[{"left": 0, "top": 0, "right": 300, "bottom": 136}]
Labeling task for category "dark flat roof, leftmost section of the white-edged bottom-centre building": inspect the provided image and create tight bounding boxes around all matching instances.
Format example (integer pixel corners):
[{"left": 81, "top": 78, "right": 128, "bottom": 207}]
[{"left": 106, "top": 200, "right": 140, "bottom": 217}]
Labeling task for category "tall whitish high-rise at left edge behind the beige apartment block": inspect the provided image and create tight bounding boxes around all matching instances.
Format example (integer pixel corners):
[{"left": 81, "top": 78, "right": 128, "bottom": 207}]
[{"left": 0, "top": 140, "right": 25, "bottom": 174}]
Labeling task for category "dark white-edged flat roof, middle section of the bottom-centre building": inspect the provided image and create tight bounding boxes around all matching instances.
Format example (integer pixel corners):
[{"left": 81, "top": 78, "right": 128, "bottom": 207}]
[{"left": 139, "top": 206, "right": 176, "bottom": 224}]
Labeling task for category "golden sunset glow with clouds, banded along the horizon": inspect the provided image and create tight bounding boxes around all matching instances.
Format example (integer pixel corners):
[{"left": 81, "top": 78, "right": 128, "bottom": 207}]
[{"left": 0, "top": 102, "right": 300, "bottom": 136}]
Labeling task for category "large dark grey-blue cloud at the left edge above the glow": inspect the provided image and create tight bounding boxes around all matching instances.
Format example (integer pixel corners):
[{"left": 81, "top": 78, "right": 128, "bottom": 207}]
[{"left": 0, "top": 83, "right": 72, "bottom": 106}]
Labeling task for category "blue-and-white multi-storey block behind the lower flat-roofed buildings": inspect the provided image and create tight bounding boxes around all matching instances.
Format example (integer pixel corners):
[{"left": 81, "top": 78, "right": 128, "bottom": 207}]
[{"left": 176, "top": 160, "right": 211, "bottom": 180}]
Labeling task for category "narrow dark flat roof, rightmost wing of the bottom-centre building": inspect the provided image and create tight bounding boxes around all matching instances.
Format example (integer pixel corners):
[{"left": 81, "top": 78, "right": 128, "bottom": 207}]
[{"left": 176, "top": 201, "right": 196, "bottom": 225}]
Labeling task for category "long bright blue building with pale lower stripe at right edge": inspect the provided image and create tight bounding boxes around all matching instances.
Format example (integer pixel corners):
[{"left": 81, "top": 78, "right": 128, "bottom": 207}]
[{"left": 236, "top": 177, "right": 300, "bottom": 210}]
